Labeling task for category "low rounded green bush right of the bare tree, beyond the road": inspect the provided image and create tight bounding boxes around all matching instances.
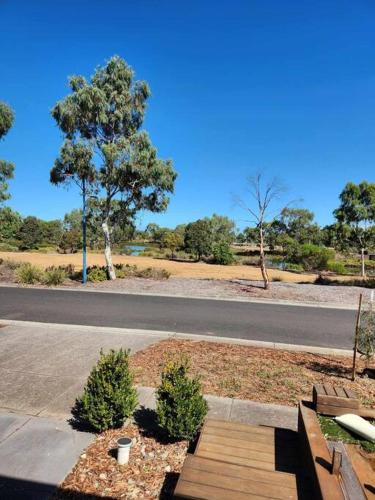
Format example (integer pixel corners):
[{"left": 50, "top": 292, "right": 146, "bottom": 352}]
[{"left": 286, "top": 243, "right": 335, "bottom": 271}]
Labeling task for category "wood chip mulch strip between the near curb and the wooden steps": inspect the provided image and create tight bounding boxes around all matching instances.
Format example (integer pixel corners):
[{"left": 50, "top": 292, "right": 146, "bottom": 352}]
[{"left": 131, "top": 339, "right": 375, "bottom": 406}]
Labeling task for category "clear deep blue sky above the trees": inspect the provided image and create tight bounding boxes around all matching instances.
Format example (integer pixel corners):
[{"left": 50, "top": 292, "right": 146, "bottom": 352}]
[{"left": 0, "top": 0, "right": 375, "bottom": 230}]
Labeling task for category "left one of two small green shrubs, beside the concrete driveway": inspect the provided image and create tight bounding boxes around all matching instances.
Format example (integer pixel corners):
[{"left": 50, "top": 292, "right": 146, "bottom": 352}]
[{"left": 76, "top": 349, "right": 138, "bottom": 432}]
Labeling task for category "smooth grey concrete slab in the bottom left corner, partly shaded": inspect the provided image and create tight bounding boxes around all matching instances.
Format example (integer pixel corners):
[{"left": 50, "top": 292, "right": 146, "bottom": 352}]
[{"left": 0, "top": 412, "right": 93, "bottom": 500}]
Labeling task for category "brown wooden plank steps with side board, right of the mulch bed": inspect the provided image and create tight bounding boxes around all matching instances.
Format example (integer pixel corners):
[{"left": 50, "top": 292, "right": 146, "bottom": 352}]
[{"left": 175, "top": 402, "right": 344, "bottom": 500}]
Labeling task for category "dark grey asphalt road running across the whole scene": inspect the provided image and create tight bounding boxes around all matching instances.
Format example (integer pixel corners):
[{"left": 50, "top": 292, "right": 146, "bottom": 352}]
[{"left": 0, "top": 287, "right": 355, "bottom": 349}]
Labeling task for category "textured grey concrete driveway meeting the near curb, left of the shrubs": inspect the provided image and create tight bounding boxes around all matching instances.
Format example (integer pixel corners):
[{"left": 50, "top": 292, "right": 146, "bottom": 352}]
[{"left": 0, "top": 322, "right": 162, "bottom": 418}]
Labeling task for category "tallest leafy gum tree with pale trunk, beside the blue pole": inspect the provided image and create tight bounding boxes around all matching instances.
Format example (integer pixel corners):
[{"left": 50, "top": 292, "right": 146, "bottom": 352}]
[{"left": 51, "top": 56, "right": 177, "bottom": 279}]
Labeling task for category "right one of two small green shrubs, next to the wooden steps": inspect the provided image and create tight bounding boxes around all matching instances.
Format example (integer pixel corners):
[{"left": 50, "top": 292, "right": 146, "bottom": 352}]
[{"left": 156, "top": 357, "right": 208, "bottom": 440}]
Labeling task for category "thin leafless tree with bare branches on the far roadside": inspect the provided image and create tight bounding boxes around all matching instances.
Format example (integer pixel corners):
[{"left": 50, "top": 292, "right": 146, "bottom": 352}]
[{"left": 235, "top": 173, "right": 285, "bottom": 290}]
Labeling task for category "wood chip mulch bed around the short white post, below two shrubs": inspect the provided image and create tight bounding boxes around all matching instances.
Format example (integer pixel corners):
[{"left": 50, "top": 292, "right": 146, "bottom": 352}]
[{"left": 54, "top": 424, "right": 188, "bottom": 500}]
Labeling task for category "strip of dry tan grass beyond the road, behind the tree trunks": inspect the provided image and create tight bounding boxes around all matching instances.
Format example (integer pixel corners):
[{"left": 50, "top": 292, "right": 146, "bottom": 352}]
[{"left": 0, "top": 252, "right": 316, "bottom": 283}]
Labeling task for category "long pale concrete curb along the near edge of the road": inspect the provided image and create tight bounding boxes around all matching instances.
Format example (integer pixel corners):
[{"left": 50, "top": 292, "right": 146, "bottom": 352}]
[{"left": 0, "top": 318, "right": 353, "bottom": 356}]
